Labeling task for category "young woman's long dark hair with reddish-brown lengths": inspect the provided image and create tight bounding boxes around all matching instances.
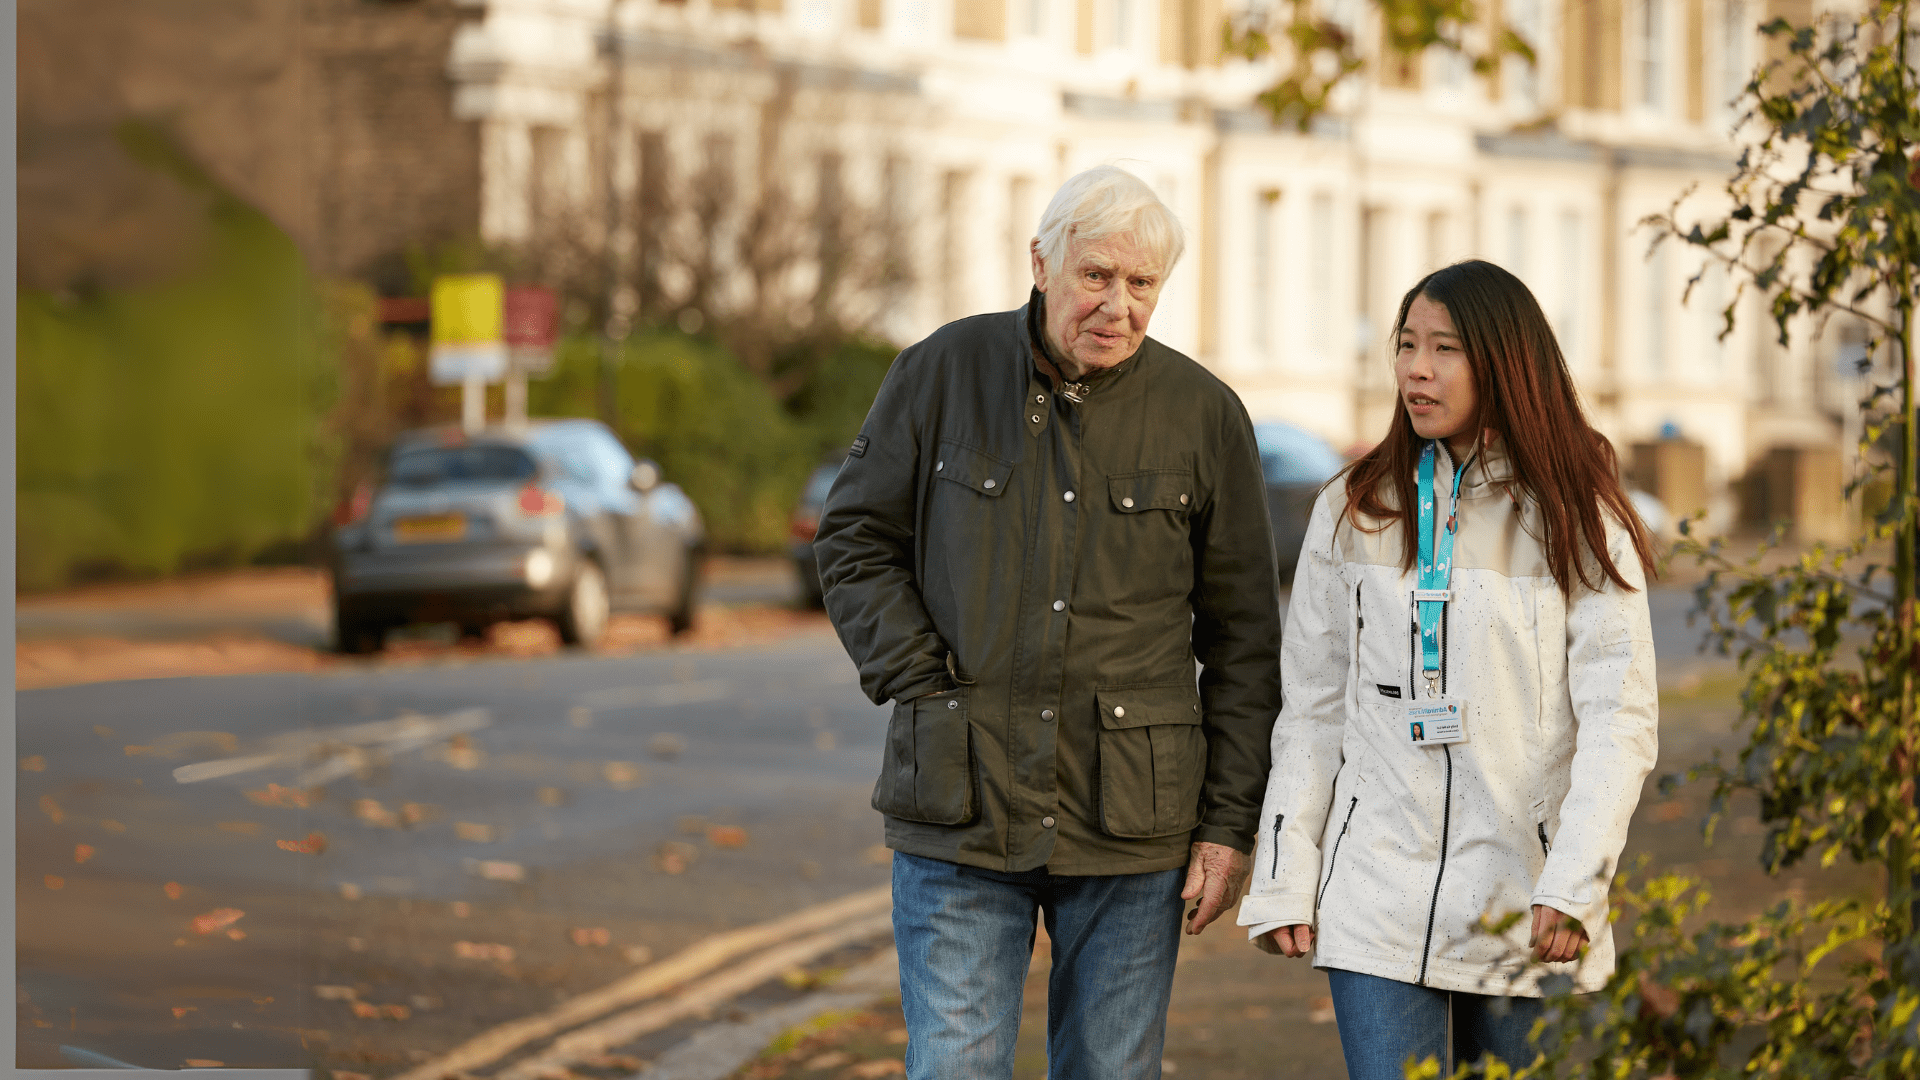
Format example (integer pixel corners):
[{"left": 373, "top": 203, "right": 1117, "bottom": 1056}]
[{"left": 1346, "top": 259, "right": 1653, "bottom": 596}]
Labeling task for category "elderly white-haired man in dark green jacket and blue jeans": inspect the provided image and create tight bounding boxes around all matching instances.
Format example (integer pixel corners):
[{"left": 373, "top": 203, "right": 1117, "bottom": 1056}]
[{"left": 814, "top": 167, "right": 1281, "bottom": 1080}]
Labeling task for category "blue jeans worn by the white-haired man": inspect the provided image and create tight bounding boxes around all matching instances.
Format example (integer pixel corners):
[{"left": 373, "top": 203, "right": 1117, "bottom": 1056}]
[{"left": 893, "top": 851, "right": 1187, "bottom": 1080}]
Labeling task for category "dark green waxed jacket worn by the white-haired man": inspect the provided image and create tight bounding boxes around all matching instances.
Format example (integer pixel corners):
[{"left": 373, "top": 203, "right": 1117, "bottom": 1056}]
[{"left": 814, "top": 295, "right": 1281, "bottom": 874}]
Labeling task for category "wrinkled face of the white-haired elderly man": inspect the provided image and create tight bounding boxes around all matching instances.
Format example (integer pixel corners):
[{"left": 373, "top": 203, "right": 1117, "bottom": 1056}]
[{"left": 1033, "top": 234, "right": 1165, "bottom": 379}]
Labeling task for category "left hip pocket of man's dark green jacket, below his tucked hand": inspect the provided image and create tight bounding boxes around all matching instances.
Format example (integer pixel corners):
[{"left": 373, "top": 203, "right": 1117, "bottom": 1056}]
[{"left": 874, "top": 686, "right": 975, "bottom": 824}]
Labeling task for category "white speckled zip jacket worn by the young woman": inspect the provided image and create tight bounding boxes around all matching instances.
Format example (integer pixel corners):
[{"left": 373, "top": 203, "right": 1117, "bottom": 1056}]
[{"left": 1238, "top": 438, "right": 1659, "bottom": 997}]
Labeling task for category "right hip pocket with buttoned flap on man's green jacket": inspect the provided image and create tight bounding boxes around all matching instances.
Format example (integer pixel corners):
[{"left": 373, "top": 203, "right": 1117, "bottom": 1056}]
[{"left": 1094, "top": 682, "right": 1208, "bottom": 838}]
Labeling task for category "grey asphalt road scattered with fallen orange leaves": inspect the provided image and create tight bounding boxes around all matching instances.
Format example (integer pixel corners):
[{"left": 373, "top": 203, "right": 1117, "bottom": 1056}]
[{"left": 15, "top": 590, "right": 1728, "bottom": 1076}]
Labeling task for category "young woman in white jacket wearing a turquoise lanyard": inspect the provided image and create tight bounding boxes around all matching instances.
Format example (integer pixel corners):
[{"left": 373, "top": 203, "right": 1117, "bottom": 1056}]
[{"left": 1240, "top": 261, "right": 1657, "bottom": 1080}]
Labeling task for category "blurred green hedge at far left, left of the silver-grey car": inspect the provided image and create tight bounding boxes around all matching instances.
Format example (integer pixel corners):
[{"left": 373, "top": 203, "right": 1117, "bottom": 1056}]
[{"left": 15, "top": 129, "right": 332, "bottom": 590}]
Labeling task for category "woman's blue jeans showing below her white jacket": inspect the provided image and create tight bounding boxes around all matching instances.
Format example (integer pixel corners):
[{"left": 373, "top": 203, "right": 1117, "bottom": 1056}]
[{"left": 1327, "top": 969, "right": 1540, "bottom": 1080}]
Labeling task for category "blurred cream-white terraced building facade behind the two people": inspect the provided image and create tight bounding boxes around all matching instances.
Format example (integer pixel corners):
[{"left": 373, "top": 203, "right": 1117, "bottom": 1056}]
[{"left": 449, "top": 0, "right": 1853, "bottom": 521}]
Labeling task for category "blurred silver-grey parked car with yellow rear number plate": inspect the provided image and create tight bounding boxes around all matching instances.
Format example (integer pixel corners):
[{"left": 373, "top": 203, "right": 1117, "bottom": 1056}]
[{"left": 332, "top": 421, "right": 705, "bottom": 653}]
